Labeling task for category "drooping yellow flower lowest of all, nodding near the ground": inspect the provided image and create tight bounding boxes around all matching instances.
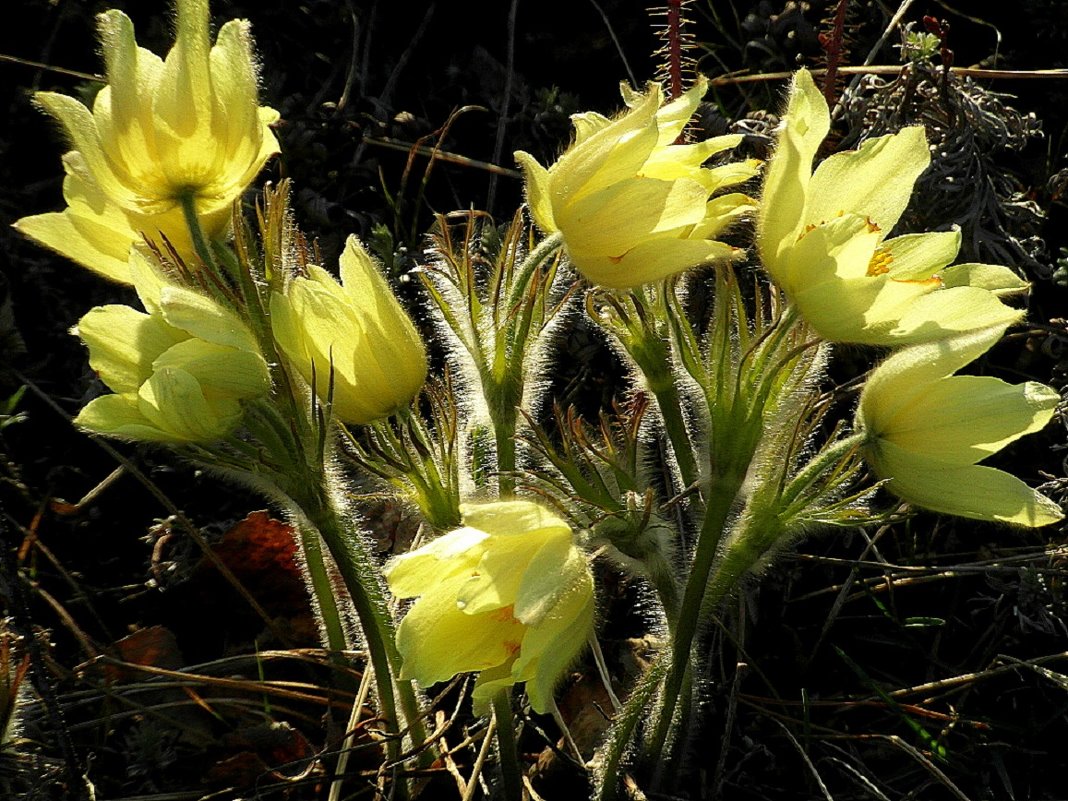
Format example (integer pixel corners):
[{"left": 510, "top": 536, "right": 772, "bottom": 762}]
[{"left": 386, "top": 501, "right": 594, "bottom": 714}]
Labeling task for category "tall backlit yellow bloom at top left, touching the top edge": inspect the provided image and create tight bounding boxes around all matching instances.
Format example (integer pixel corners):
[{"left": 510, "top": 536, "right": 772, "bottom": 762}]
[{"left": 16, "top": 0, "right": 278, "bottom": 283}]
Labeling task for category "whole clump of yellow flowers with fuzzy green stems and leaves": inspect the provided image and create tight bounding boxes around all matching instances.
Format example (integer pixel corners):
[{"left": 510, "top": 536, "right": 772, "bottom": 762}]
[{"left": 16, "top": 0, "right": 1063, "bottom": 798}]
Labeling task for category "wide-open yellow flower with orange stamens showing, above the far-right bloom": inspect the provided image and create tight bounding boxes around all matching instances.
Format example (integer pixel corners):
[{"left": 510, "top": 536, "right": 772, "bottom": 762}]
[{"left": 757, "top": 69, "right": 1027, "bottom": 345}]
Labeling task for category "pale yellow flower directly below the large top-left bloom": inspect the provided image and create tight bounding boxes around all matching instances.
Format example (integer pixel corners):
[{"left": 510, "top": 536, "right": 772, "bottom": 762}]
[{"left": 73, "top": 250, "right": 270, "bottom": 443}]
